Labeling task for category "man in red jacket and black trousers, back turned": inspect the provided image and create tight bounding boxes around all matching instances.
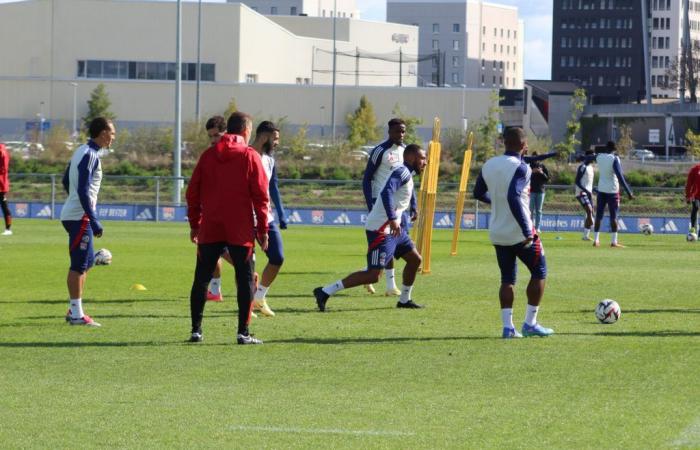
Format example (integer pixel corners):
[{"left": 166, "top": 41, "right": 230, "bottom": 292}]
[{"left": 187, "top": 112, "right": 270, "bottom": 345}]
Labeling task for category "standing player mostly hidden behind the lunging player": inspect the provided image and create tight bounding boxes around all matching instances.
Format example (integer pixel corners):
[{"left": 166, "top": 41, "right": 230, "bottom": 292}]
[{"left": 362, "top": 118, "right": 416, "bottom": 296}]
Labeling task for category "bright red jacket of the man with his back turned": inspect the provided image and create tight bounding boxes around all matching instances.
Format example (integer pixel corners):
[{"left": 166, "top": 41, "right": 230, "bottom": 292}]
[{"left": 187, "top": 134, "right": 270, "bottom": 247}]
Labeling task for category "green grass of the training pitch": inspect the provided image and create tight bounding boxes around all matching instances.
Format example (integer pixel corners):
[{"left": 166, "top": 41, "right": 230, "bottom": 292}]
[{"left": 0, "top": 220, "right": 700, "bottom": 448}]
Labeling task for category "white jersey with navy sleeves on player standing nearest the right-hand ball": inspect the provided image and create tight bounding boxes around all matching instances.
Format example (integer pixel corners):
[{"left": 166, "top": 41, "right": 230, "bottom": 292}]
[{"left": 481, "top": 154, "right": 533, "bottom": 246}]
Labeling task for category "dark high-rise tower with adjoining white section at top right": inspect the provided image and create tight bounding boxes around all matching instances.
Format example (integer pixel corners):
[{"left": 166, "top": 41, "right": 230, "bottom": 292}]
[{"left": 552, "top": 0, "right": 700, "bottom": 103}]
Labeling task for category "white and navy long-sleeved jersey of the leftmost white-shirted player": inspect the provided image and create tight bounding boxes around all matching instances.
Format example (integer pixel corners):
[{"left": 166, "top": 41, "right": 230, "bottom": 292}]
[{"left": 61, "top": 144, "right": 102, "bottom": 220}]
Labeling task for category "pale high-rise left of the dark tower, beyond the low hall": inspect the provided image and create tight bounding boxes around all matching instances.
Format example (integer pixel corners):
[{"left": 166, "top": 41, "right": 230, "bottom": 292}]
[{"left": 387, "top": 0, "right": 524, "bottom": 89}]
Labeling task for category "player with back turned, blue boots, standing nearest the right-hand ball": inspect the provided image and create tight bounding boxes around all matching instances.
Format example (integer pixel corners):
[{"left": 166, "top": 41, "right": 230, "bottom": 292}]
[{"left": 474, "top": 128, "right": 554, "bottom": 339}]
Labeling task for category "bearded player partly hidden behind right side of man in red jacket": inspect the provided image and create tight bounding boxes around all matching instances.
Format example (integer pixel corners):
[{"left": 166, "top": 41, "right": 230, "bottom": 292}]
[{"left": 252, "top": 120, "right": 287, "bottom": 317}]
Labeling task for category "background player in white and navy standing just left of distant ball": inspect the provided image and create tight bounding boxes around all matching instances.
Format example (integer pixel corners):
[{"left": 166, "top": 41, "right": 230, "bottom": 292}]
[{"left": 586, "top": 141, "right": 634, "bottom": 248}]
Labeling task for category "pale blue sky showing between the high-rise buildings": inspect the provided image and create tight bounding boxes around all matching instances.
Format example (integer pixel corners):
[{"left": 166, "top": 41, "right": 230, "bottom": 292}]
[{"left": 0, "top": 0, "right": 552, "bottom": 80}]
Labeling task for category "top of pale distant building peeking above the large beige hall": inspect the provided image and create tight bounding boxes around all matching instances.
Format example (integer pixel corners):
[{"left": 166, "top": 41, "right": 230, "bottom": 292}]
[{"left": 228, "top": 0, "right": 360, "bottom": 19}]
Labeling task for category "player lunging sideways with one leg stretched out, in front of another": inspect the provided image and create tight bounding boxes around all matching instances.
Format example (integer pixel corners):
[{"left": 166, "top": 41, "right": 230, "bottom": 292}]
[{"left": 314, "top": 144, "right": 426, "bottom": 311}]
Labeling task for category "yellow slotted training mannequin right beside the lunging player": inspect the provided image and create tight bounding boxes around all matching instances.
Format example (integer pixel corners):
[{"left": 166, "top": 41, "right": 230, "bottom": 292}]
[{"left": 413, "top": 117, "right": 442, "bottom": 275}]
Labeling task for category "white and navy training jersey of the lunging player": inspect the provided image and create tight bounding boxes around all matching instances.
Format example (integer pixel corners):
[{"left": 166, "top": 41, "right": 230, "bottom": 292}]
[{"left": 365, "top": 164, "right": 413, "bottom": 234}]
